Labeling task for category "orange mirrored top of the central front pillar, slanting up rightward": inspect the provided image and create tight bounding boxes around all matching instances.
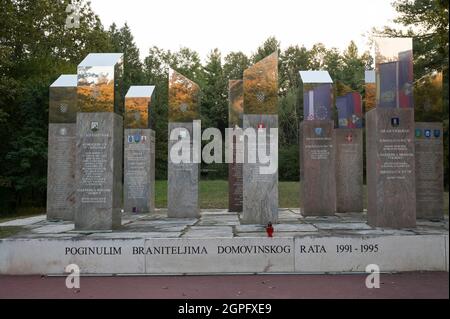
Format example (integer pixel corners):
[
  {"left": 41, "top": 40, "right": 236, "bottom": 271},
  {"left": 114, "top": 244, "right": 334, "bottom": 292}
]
[{"left": 244, "top": 52, "right": 278, "bottom": 114}]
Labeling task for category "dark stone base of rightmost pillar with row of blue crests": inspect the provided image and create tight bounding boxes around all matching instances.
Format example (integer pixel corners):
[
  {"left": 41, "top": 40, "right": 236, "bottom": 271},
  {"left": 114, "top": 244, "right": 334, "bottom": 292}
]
[{"left": 415, "top": 122, "right": 444, "bottom": 219}]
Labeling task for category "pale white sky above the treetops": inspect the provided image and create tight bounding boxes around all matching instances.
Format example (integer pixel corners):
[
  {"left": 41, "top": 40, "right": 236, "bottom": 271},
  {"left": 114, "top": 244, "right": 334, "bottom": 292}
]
[{"left": 90, "top": 0, "right": 396, "bottom": 60}]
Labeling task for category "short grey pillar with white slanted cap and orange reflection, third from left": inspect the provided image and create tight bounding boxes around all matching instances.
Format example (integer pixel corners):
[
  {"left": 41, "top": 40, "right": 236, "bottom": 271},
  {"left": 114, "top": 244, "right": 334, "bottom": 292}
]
[{"left": 123, "top": 86, "right": 155, "bottom": 213}]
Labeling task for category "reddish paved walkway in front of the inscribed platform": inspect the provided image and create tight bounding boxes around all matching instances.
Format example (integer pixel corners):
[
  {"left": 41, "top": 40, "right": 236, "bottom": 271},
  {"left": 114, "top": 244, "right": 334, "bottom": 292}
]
[{"left": 0, "top": 272, "right": 449, "bottom": 299}]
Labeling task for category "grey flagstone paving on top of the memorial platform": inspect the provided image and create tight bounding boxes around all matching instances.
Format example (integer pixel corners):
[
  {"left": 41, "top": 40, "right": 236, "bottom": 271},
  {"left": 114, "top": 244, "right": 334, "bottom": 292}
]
[{"left": 0, "top": 208, "right": 448, "bottom": 238}]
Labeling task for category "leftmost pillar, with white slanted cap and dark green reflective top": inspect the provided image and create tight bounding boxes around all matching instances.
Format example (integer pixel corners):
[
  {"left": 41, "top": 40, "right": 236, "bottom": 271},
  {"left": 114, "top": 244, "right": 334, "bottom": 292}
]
[{"left": 47, "top": 75, "right": 77, "bottom": 221}]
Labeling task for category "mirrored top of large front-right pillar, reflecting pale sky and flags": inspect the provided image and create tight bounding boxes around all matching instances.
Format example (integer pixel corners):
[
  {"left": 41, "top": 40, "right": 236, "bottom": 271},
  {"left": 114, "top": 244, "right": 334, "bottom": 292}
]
[{"left": 375, "top": 38, "right": 414, "bottom": 108}]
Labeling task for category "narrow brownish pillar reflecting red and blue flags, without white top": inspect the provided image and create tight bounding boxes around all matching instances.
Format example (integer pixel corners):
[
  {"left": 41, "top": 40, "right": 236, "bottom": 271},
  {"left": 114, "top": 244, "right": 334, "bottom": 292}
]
[{"left": 335, "top": 92, "right": 363, "bottom": 213}]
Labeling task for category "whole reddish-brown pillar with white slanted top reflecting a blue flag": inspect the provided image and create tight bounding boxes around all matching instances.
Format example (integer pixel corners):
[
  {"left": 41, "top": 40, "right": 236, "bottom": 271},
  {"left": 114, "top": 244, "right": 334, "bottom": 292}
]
[{"left": 299, "top": 71, "right": 336, "bottom": 216}]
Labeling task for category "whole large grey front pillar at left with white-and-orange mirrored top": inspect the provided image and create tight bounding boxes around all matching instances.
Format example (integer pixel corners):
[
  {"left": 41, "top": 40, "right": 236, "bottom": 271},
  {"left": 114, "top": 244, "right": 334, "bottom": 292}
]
[{"left": 75, "top": 53, "right": 123, "bottom": 231}]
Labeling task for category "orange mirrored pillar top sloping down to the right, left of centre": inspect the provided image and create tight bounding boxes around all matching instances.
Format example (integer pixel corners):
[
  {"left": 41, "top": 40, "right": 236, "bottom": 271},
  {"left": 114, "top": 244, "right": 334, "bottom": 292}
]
[{"left": 169, "top": 69, "right": 200, "bottom": 122}]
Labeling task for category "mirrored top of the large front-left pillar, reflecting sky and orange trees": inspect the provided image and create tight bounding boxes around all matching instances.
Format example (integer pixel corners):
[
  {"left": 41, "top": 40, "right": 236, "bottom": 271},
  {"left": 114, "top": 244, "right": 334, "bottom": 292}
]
[{"left": 77, "top": 53, "right": 124, "bottom": 115}]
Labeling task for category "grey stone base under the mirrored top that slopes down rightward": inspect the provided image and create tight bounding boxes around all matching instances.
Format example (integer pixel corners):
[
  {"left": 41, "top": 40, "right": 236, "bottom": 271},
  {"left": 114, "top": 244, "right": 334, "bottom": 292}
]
[{"left": 167, "top": 123, "right": 200, "bottom": 218}]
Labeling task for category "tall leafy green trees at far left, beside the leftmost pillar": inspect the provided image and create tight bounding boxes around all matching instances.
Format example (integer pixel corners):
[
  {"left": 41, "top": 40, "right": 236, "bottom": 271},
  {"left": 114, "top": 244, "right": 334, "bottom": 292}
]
[{"left": 0, "top": 0, "right": 111, "bottom": 214}]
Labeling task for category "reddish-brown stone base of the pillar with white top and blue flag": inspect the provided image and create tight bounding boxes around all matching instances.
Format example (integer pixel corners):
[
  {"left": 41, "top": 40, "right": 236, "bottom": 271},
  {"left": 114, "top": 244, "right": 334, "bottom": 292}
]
[{"left": 300, "top": 120, "right": 336, "bottom": 216}]
